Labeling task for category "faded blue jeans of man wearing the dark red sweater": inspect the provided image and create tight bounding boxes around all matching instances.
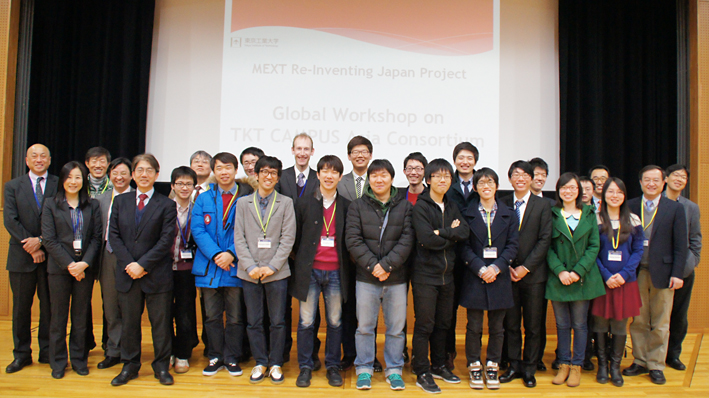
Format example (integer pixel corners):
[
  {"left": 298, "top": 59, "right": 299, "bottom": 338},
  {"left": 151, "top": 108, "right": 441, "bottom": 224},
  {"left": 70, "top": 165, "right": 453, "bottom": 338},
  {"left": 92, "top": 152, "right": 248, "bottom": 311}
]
[{"left": 298, "top": 269, "right": 342, "bottom": 370}]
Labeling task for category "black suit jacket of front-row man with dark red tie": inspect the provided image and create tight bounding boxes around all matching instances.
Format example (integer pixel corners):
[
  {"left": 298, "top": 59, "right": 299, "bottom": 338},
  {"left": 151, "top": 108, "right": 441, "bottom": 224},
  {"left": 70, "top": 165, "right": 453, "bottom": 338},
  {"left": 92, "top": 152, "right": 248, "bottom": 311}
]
[{"left": 108, "top": 191, "right": 177, "bottom": 293}]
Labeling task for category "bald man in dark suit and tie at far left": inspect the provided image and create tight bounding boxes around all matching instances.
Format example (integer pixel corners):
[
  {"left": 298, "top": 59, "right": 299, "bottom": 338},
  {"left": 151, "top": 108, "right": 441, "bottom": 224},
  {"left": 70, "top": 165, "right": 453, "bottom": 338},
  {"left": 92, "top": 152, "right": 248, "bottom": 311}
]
[{"left": 4, "top": 144, "right": 58, "bottom": 373}]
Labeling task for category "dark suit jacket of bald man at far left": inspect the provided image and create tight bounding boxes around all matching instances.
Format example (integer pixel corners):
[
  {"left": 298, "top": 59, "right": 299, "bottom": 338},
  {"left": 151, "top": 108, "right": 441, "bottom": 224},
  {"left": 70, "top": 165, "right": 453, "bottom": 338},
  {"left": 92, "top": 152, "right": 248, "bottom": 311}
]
[{"left": 3, "top": 174, "right": 59, "bottom": 272}]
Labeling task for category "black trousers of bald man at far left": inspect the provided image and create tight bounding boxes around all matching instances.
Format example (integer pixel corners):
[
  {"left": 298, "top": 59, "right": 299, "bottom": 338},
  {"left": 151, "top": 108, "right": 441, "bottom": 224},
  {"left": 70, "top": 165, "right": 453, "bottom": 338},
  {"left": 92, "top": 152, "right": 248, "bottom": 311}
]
[{"left": 10, "top": 262, "right": 51, "bottom": 361}]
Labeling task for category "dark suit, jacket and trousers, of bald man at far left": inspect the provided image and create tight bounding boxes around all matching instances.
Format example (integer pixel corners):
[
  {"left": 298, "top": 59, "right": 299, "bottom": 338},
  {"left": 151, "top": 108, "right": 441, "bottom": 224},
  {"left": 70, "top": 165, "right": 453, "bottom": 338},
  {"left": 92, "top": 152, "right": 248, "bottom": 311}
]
[{"left": 3, "top": 174, "right": 59, "bottom": 362}]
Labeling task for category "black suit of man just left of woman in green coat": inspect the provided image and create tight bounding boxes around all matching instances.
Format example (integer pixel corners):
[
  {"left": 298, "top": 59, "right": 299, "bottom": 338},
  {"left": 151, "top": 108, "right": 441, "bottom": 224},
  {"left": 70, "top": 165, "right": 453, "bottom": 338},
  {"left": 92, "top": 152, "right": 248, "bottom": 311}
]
[{"left": 501, "top": 194, "right": 552, "bottom": 375}]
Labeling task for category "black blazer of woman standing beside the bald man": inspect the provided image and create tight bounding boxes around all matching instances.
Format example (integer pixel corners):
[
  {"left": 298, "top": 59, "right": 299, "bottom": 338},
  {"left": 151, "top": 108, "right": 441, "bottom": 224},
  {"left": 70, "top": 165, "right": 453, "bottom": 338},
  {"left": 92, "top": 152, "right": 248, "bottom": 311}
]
[{"left": 42, "top": 198, "right": 103, "bottom": 278}]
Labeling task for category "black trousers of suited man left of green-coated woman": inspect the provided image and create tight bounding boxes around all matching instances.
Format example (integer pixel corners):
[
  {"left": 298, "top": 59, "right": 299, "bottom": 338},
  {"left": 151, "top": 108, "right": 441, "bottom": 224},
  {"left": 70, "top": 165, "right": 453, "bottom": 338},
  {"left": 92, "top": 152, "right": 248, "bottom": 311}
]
[{"left": 504, "top": 282, "right": 546, "bottom": 375}]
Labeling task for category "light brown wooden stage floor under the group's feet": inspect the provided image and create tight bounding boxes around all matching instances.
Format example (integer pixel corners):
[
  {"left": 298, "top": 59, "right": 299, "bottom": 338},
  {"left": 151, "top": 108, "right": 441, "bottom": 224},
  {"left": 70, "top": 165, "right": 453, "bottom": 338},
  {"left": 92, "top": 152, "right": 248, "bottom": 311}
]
[{"left": 0, "top": 321, "right": 709, "bottom": 398}]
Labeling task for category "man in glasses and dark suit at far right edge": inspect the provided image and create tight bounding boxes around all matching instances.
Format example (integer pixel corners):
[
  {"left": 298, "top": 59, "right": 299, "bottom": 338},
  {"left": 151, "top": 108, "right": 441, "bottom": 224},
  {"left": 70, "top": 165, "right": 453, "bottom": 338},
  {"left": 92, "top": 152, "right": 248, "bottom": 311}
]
[{"left": 665, "top": 164, "right": 702, "bottom": 370}]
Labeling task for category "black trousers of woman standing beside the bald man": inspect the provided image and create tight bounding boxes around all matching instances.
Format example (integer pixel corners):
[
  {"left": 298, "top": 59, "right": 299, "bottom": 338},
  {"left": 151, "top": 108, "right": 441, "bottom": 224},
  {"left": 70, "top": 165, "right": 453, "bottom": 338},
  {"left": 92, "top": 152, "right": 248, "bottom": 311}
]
[{"left": 48, "top": 274, "right": 94, "bottom": 371}]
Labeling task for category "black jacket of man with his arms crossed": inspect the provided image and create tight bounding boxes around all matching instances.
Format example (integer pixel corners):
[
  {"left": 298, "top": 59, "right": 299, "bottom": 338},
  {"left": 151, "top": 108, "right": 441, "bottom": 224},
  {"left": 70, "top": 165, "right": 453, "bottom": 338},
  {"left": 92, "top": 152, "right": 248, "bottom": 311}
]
[{"left": 411, "top": 191, "right": 470, "bottom": 286}]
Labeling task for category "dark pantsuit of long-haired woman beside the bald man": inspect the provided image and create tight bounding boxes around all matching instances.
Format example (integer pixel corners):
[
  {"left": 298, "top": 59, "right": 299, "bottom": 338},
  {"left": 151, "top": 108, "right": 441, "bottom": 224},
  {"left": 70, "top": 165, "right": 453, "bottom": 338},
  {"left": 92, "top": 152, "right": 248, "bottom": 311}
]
[{"left": 42, "top": 198, "right": 103, "bottom": 371}]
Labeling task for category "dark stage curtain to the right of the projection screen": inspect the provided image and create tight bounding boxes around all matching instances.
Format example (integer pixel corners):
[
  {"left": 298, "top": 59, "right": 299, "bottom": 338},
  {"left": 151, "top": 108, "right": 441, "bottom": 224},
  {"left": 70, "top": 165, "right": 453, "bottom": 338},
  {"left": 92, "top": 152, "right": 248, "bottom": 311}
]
[{"left": 559, "top": 0, "right": 682, "bottom": 196}]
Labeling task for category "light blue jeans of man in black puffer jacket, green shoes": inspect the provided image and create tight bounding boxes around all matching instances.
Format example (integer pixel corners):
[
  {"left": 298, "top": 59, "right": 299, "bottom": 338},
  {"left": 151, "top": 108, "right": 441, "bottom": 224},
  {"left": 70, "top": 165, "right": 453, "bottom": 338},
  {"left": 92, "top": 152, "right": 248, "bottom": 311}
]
[{"left": 355, "top": 281, "right": 407, "bottom": 376}]
